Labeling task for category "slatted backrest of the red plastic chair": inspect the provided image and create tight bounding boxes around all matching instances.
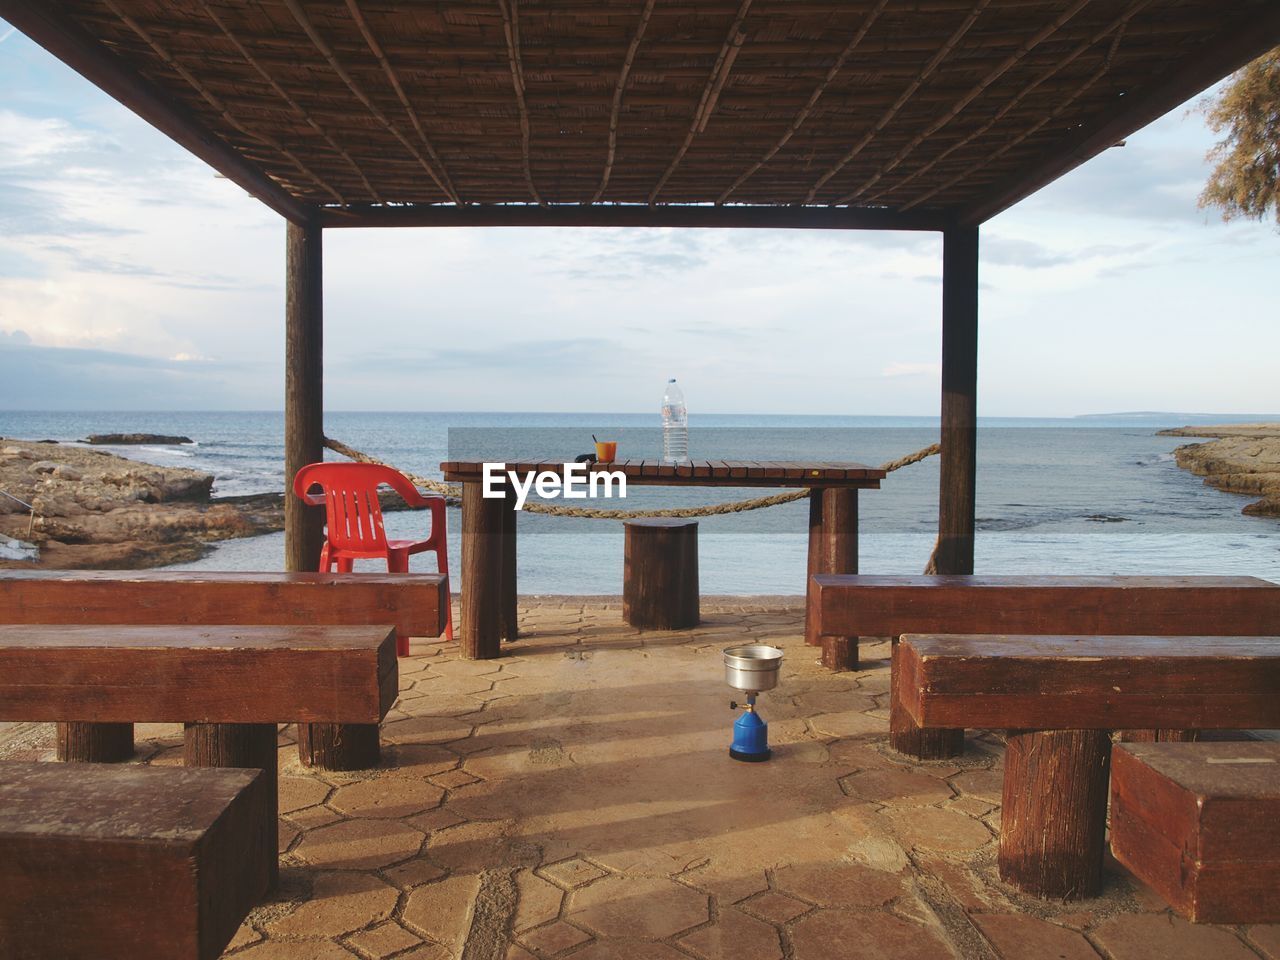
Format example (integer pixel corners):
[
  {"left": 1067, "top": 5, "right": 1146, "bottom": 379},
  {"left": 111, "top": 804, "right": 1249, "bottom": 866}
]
[{"left": 293, "top": 463, "right": 416, "bottom": 550}]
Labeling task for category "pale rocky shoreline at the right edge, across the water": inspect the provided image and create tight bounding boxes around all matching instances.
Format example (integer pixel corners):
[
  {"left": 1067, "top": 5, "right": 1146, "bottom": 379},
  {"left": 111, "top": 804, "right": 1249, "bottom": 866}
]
[{"left": 1160, "top": 424, "right": 1280, "bottom": 517}]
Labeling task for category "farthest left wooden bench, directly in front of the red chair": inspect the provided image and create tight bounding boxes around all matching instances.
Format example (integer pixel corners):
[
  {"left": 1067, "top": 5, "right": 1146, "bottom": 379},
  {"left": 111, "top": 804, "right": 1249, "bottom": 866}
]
[{"left": 0, "top": 570, "right": 449, "bottom": 769}]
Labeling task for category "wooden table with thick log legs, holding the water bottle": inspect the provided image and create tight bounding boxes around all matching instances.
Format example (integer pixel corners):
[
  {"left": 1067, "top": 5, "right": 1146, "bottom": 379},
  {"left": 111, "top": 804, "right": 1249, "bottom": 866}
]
[{"left": 440, "top": 460, "right": 884, "bottom": 659}]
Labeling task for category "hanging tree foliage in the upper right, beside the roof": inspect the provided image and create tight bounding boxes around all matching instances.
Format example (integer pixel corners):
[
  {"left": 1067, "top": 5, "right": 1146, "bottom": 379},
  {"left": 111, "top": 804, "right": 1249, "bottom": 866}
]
[{"left": 1199, "top": 47, "right": 1280, "bottom": 225}]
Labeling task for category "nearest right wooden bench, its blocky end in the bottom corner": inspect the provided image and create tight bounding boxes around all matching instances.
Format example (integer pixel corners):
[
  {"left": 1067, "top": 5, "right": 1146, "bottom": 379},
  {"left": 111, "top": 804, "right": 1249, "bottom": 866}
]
[{"left": 1111, "top": 742, "right": 1280, "bottom": 924}]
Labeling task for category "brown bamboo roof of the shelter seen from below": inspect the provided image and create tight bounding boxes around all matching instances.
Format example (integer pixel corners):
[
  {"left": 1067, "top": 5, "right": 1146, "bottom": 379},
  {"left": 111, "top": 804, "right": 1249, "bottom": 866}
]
[{"left": 10, "top": 0, "right": 1280, "bottom": 228}]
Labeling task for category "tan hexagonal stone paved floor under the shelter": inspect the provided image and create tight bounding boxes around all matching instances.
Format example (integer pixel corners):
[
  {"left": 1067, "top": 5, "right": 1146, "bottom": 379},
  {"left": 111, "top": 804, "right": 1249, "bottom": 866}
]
[{"left": 0, "top": 598, "right": 1280, "bottom": 960}]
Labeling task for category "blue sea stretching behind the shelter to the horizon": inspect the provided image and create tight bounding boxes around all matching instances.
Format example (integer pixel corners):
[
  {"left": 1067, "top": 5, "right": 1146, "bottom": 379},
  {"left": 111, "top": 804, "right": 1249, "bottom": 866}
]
[{"left": 0, "top": 411, "right": 1280, "bottom": 595}]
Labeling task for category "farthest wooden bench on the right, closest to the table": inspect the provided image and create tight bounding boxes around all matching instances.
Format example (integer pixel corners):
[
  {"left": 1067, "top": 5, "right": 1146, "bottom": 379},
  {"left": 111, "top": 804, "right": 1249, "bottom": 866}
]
[{"left": 809, "top": 575, "right": 1280, "bottom": 759}]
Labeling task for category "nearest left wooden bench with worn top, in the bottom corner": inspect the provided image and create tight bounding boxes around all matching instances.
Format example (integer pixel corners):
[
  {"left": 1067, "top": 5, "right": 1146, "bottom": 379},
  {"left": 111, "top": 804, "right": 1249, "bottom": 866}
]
[{"left": 0, "top": 763, "right": 275, "bottom": 960}]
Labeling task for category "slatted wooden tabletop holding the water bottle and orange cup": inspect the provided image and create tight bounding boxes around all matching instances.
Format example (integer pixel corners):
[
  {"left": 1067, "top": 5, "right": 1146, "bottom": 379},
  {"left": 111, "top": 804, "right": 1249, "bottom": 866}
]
[{"left": 440, "top": 460, "right": 886, "bottom": 490}]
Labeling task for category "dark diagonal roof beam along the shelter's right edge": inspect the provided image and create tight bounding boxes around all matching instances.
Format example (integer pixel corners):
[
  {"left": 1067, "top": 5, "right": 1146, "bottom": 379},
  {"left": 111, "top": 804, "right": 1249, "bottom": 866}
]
[{"left": 959, "top": 4, "right": 1280, "bottom": 225}]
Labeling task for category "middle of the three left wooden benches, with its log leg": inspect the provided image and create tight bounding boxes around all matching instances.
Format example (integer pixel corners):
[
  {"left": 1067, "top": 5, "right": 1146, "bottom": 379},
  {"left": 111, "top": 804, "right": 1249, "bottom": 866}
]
[{"left": 0, "top": 625, "right": 398, "bottom": 890}]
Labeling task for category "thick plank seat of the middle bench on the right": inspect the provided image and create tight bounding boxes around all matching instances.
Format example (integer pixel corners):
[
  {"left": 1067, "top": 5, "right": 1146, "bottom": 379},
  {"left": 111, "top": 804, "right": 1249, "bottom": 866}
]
[{"left": 897, "top": 634, "right": 1280, "bottom": 730}]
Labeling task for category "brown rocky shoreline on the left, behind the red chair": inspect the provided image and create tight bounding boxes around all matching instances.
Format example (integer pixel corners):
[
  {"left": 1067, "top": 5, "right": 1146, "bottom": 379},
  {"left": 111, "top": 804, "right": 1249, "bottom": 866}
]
[{"left": 0, "top": 438, "right": 284, "bottom": 570}]
